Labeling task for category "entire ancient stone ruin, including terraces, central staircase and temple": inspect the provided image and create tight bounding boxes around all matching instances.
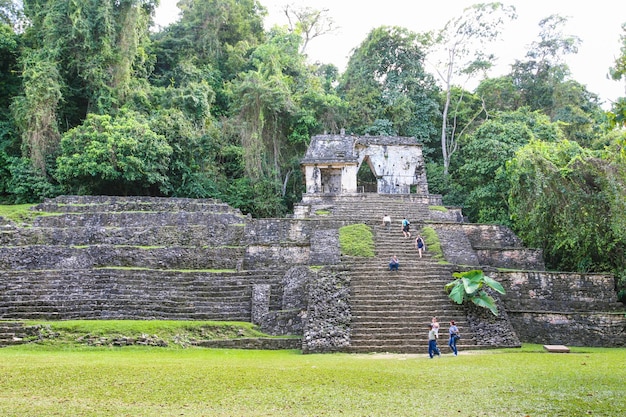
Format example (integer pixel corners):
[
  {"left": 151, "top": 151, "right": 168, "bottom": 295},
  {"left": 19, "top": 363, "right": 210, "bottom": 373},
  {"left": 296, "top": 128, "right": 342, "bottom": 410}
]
[{"left": 0, "top": 134, "right": 626, "bottom": 353}]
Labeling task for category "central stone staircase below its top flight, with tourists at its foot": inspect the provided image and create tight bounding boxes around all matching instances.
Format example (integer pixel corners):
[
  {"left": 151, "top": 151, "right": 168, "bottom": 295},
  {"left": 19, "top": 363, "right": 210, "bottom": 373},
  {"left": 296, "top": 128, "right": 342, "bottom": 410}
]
[{"left": 350, "top": 225, "right": 481, "bottom": 353}]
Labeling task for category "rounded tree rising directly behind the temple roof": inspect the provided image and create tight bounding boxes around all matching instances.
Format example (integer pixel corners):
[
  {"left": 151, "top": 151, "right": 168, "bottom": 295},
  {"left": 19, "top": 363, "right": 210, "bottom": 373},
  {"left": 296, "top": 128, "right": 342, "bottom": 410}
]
[{"left": 338, "top": 26, "right": 438, "bottom": 142}]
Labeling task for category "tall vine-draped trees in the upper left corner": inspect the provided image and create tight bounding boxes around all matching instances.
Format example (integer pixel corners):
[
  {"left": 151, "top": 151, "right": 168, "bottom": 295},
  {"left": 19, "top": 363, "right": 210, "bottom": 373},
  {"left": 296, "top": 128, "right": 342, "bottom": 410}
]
[{"left": 13, "top": 0, "right": 156, "bottom": 173}]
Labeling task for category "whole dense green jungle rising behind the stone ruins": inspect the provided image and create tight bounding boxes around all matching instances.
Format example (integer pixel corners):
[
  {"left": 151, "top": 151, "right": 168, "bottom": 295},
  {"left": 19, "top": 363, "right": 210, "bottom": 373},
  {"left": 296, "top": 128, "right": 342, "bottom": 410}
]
[{"left": 0, "top": 0, "right": 626, "bottom": 296}]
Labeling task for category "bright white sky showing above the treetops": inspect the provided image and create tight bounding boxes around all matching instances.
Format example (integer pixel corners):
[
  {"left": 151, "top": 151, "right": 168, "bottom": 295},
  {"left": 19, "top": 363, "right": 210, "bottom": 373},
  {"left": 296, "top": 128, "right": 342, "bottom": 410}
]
[{"left": 155, "top": 0, "right": 626, "bottom": 109}]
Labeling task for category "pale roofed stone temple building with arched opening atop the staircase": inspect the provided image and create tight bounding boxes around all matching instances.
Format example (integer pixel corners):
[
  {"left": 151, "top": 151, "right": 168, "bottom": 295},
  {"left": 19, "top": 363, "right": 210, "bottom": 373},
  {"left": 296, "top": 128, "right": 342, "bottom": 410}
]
[{"left": 301, "top": 132, "right": 428, "bottom": 195}]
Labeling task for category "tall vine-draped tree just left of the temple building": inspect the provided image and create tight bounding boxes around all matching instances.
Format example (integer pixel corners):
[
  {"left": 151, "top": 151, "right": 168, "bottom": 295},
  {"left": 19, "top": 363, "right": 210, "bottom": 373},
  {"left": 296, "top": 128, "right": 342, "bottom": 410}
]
[{"left": 229, "top": 27, "right": 341, "bottom": 214}]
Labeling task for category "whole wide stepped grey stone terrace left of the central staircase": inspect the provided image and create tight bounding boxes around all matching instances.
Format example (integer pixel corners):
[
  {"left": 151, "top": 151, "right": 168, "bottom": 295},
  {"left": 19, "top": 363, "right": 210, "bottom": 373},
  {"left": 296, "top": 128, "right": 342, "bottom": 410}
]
[{"left": 0, "top": 196, "right": 284, "bottom": 321}]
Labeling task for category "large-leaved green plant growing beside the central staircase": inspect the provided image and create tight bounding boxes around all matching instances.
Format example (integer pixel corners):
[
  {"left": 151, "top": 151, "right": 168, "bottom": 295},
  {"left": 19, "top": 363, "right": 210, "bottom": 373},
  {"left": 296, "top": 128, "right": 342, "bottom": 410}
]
[{"left": 444, "top": 269, "right": 506, "bottom": 316}]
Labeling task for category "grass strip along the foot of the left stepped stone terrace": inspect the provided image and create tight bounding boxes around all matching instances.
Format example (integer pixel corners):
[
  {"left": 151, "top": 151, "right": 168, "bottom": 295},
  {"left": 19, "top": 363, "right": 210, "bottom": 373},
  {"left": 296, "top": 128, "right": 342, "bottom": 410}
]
[{"left": 26, "top": 320, "right": 270, "bottom": 347}]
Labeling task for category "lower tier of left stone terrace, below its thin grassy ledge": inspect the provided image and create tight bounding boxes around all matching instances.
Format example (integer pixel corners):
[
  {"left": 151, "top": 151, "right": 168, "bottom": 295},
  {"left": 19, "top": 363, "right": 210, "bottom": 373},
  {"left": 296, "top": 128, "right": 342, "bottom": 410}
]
[{"left": 0, "top": 269, "right": 282, "bottom": 321}]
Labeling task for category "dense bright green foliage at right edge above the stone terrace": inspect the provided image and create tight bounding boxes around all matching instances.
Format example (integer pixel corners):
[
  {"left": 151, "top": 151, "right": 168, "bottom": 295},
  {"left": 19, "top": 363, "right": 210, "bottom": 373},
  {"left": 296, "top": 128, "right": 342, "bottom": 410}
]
[{"left": 507, "top": 140, "right": 626, "bottom": 290}]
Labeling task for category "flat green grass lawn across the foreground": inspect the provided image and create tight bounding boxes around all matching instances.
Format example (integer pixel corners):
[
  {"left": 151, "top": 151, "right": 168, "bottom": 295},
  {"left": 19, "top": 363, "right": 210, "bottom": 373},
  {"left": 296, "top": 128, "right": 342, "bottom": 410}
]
[{"left": 0, "top": 345, "right": 626, "bottom": 417}]
